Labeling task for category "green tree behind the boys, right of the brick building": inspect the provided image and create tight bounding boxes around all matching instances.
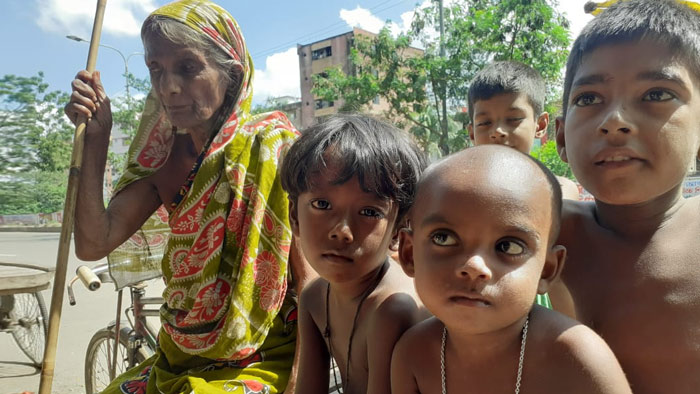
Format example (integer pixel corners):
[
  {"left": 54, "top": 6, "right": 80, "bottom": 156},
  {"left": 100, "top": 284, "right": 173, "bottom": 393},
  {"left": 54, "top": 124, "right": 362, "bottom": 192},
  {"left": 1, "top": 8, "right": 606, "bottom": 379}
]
[{"left": 313, "top": 0, "right": 570, "bottom": 155}]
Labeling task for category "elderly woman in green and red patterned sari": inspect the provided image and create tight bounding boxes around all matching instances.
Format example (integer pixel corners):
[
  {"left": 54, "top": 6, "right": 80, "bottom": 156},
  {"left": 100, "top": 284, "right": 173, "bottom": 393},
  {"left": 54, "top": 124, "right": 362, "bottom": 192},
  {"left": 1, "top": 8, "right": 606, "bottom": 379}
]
[{"left": 65, "top": 0, "right": 306, "bottom": 393}]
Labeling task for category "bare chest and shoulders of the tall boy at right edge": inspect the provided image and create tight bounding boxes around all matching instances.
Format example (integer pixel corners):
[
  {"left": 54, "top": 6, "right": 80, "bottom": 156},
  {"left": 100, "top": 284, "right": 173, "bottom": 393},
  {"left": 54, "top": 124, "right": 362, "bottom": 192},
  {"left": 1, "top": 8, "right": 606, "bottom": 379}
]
[{"left": 563, "top": 225, "right": 700, "bottom": 393}]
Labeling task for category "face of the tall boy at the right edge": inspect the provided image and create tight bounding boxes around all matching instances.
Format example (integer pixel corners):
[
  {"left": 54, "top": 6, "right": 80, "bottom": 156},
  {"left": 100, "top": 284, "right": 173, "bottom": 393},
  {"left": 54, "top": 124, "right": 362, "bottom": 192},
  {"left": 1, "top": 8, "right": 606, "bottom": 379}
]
[{"left": 557, "top": 41, "right": 700, "bottom": 205}]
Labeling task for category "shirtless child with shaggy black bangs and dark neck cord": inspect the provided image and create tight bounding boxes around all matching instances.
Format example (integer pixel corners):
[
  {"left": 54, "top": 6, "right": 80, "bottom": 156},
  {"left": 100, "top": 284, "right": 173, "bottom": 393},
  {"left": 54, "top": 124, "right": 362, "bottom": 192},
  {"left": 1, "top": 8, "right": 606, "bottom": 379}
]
[{"left": 282, "top": 115, "right": 428, "bottom": 394}]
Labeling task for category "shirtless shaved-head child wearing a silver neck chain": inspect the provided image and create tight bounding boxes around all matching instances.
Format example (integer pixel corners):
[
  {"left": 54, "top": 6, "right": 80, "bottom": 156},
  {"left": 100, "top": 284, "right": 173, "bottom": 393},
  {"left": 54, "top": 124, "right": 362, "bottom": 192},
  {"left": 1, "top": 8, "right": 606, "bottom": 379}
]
[{"left": 391, "top": 146, "right": 631, "bottom": 394}]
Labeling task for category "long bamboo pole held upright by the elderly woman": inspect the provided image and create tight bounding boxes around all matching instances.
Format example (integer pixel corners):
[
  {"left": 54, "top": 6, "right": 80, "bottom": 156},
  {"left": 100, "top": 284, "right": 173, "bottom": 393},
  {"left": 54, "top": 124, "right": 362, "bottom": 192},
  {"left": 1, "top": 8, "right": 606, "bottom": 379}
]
[{"left": 39, "top": 0, "right": 107, "bottom": 394}]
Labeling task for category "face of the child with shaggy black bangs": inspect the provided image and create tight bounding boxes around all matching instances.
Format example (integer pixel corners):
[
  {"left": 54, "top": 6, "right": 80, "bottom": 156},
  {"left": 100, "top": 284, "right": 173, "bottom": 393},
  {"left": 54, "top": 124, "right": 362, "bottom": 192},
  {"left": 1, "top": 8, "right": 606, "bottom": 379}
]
[{"left": 291, "top": 163, "right": 398, "bottom": 283}]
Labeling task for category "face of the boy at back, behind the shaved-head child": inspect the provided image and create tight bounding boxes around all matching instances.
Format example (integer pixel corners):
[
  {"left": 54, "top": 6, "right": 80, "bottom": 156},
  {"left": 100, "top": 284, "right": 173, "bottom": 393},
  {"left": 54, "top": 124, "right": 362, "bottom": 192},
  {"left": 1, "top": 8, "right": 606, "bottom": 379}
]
[{"left": 469, "top": 93, "right": 549, "bottom": 154}]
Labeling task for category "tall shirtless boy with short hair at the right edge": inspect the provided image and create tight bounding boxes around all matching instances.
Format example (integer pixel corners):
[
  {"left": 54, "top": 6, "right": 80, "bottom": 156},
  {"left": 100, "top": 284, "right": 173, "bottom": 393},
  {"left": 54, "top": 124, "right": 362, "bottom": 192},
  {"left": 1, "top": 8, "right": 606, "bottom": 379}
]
[{"left": 552, "top": 0, "right": 700, "bottom": 394}]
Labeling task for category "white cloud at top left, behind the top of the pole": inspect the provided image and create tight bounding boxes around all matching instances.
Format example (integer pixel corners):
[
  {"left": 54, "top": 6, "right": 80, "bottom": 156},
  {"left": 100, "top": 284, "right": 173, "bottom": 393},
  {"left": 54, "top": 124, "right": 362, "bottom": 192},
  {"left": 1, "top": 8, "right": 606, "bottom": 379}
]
[{"left": 37, "top": 0, "right": 157, "bottom": 39}]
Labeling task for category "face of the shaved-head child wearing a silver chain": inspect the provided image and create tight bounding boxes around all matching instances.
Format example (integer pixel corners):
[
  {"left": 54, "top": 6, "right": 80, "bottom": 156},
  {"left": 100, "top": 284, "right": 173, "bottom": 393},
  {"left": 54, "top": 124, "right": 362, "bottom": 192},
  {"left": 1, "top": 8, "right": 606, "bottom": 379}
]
[{"left": 400, "top": 152, "right": 563, "bottom": 334}]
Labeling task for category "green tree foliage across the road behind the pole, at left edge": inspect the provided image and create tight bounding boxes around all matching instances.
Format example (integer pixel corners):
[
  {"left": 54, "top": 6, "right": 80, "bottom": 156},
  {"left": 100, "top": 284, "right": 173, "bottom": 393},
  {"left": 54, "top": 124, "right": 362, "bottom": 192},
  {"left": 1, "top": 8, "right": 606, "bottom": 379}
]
[{"left": 0, "top": 72, "right": 150, "bottom": 214}]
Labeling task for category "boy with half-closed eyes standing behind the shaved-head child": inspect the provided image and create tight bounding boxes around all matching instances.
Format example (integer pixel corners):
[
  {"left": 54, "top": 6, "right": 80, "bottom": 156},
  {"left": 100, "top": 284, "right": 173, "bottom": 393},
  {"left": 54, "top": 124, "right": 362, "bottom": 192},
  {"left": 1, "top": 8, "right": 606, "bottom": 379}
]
[{"left": 468, "top": 61, "right": 579, "bottom": 200}]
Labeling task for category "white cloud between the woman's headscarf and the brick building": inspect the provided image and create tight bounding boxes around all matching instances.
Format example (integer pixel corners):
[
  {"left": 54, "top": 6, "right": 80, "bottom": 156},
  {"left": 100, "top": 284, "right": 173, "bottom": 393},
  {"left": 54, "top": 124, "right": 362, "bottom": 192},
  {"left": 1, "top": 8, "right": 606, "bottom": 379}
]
[{"left": 253, "top": 47, "right": 301, "bottom": 103}]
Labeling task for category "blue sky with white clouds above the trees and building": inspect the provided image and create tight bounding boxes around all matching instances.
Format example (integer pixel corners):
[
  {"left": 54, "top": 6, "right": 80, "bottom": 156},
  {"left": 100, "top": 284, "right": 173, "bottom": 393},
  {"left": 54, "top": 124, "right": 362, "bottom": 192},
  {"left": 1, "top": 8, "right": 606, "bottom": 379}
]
[{"left": 0, "top": 0, "right": 590, "bottom": 103}]
